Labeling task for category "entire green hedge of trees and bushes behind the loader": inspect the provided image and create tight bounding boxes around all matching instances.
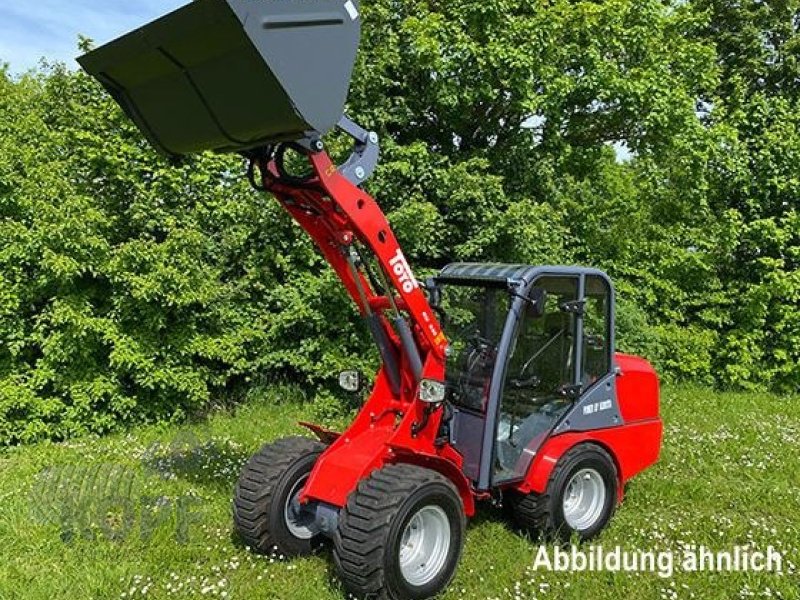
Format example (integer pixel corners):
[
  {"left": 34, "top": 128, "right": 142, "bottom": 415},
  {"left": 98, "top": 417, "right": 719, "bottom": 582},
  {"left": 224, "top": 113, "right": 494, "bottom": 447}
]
[{"left": 0, "top": 0, "right": 800, "bottom": 444}]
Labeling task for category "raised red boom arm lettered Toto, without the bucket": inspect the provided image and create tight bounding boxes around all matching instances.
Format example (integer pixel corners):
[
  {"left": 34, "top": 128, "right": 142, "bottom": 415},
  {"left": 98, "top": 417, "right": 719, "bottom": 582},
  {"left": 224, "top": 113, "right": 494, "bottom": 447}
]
[{"left": 254, "top": 142, "right": 447, "bottom": 398}]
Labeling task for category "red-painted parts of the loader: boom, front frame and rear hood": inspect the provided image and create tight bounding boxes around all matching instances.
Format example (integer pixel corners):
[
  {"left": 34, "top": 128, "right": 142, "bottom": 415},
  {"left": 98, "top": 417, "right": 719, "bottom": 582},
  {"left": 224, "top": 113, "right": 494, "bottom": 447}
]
[{"left": 259, "top": 152, "right": 662, "bottom": 516}]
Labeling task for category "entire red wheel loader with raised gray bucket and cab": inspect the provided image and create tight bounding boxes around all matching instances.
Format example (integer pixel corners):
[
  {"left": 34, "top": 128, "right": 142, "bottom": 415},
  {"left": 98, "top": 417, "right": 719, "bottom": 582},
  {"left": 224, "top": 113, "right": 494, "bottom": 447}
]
[{"left": 79, "top": 0, "right": 662, "bottom": 599}]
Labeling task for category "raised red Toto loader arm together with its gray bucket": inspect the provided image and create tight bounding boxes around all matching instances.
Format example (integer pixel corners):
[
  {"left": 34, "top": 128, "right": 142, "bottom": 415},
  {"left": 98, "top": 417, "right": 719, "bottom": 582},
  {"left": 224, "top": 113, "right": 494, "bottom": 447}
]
[{"left": 79, "top": 0, "right": 446, "bottom": 400}]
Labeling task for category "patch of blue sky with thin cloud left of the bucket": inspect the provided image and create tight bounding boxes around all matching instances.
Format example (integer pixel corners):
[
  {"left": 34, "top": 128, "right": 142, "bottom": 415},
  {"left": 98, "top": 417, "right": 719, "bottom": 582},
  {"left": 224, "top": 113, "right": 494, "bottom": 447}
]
[{"left": 0, "top": 0, "right": 189, "bottom": 73}]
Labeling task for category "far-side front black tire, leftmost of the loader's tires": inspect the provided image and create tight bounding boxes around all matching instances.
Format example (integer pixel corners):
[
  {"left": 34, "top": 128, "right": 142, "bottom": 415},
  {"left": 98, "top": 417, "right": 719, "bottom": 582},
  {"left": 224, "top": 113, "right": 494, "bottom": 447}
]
[{"left": 233, "top": 437, "right": 325, "bottom": 556}]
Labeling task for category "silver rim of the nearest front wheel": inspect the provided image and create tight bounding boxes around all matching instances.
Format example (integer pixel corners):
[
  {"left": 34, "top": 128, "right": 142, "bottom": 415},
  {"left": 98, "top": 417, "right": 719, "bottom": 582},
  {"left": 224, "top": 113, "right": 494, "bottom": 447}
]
[{"left": 400, "top": 505, "right": 450, "bottom": 586}]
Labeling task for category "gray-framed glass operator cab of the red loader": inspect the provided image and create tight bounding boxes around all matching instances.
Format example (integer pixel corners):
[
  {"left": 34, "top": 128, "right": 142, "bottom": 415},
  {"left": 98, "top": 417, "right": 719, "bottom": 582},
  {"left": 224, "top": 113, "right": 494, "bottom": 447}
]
[{"left": 433, "top": 263, "right": 622, "bottom": 489}]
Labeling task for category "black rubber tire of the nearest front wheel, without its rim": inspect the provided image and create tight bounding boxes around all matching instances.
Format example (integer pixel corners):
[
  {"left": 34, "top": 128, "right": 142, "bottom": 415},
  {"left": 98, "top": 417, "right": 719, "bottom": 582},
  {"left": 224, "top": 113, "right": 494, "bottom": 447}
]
[{"left": 333, "top": 465, "right": 466, "bottom": 600}]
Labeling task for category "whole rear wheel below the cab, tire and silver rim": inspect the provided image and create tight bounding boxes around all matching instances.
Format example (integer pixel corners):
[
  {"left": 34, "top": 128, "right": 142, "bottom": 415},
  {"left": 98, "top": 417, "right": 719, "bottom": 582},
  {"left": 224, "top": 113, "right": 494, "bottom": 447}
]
[{"left": 511, "top": 444, "right": 618, "bottom": 541}]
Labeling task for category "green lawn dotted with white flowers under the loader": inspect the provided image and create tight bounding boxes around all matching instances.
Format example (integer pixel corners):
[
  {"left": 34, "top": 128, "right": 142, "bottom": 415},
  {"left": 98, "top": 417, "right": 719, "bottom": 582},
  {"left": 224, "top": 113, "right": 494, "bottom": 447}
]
[{"left": 0, "top": 387, "right": 800, "bottom": 600}]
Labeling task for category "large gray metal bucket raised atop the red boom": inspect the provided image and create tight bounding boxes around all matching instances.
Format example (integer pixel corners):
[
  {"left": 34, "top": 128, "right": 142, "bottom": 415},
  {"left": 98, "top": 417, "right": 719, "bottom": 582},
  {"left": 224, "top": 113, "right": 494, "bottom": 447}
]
[{"left": 78, "top": 0, "right": 361, "bottom": 155}]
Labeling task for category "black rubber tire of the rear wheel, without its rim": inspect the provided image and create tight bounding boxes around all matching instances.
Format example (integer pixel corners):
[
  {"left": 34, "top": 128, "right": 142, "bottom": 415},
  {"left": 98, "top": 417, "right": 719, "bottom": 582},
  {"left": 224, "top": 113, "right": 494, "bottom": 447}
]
[{"left": 510, "top": 444, "right": 619, "bottom": 542}]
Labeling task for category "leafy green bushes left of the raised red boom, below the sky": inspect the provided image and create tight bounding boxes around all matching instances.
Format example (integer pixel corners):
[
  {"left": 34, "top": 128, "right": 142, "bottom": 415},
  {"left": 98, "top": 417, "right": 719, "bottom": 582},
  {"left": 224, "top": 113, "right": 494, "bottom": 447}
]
[{"left": 0, "top": 66, "right": 365, "bottom": 443}]
